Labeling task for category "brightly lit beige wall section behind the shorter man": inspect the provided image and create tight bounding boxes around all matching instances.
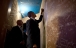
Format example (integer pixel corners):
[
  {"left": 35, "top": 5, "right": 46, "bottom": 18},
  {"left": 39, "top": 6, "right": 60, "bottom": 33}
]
[{"left": 7, "top": 0, "right": 21, "bottom": 30}]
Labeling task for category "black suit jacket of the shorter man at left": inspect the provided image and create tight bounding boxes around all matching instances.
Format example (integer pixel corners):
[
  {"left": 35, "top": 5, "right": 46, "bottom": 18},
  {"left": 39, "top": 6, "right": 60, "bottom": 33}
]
[{"left": 11, "top": 26, "right": 26, "bottom": 48}]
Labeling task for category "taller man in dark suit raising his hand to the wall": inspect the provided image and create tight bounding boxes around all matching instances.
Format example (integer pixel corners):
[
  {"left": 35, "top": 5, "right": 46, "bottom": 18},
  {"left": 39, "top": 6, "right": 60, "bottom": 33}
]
[{"left": 26, "top": 9, "right": 44, "bottom": 48}]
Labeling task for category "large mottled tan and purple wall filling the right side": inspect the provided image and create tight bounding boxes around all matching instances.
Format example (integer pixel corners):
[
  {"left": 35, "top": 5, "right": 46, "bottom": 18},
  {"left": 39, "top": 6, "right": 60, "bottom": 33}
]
[{"left": 44, "top": 0, "right": 76, "bottom": 48}]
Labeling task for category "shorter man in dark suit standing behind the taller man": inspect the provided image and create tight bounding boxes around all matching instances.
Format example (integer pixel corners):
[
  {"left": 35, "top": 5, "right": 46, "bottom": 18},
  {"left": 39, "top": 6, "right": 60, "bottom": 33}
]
[{"left": 11, "top": 20, "right": 26, "bottom": 48}]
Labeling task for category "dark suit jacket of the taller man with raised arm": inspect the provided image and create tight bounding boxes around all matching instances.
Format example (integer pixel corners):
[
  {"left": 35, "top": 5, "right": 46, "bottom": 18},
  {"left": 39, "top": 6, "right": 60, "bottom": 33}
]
[{"left": 26, "top": 15, "right": 43, "bottom": 45}]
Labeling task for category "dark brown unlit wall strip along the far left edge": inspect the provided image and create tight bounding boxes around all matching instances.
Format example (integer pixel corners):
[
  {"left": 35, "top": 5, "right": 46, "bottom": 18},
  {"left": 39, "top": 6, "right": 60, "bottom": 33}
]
[{"left": 0, "top": 0, "right": 10, "bottom": 48}]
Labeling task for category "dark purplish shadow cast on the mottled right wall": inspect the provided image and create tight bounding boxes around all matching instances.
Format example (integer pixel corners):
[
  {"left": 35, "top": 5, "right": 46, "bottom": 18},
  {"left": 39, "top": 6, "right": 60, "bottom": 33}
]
[{"left": 56, "top": 9, "right": 76, "bottom": 48}]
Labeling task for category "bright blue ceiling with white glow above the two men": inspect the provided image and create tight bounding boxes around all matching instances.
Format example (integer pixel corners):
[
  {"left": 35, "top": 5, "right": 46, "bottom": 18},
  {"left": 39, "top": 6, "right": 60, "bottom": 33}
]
[{"left": 18, "top": 0, "right": 42, "bottom": 18}]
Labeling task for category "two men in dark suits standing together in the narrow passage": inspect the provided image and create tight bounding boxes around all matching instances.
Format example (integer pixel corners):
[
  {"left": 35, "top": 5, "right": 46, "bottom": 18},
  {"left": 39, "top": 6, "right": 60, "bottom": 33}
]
[{"left": 4, "top": 9, "right": 44, "bottom": 48}]
